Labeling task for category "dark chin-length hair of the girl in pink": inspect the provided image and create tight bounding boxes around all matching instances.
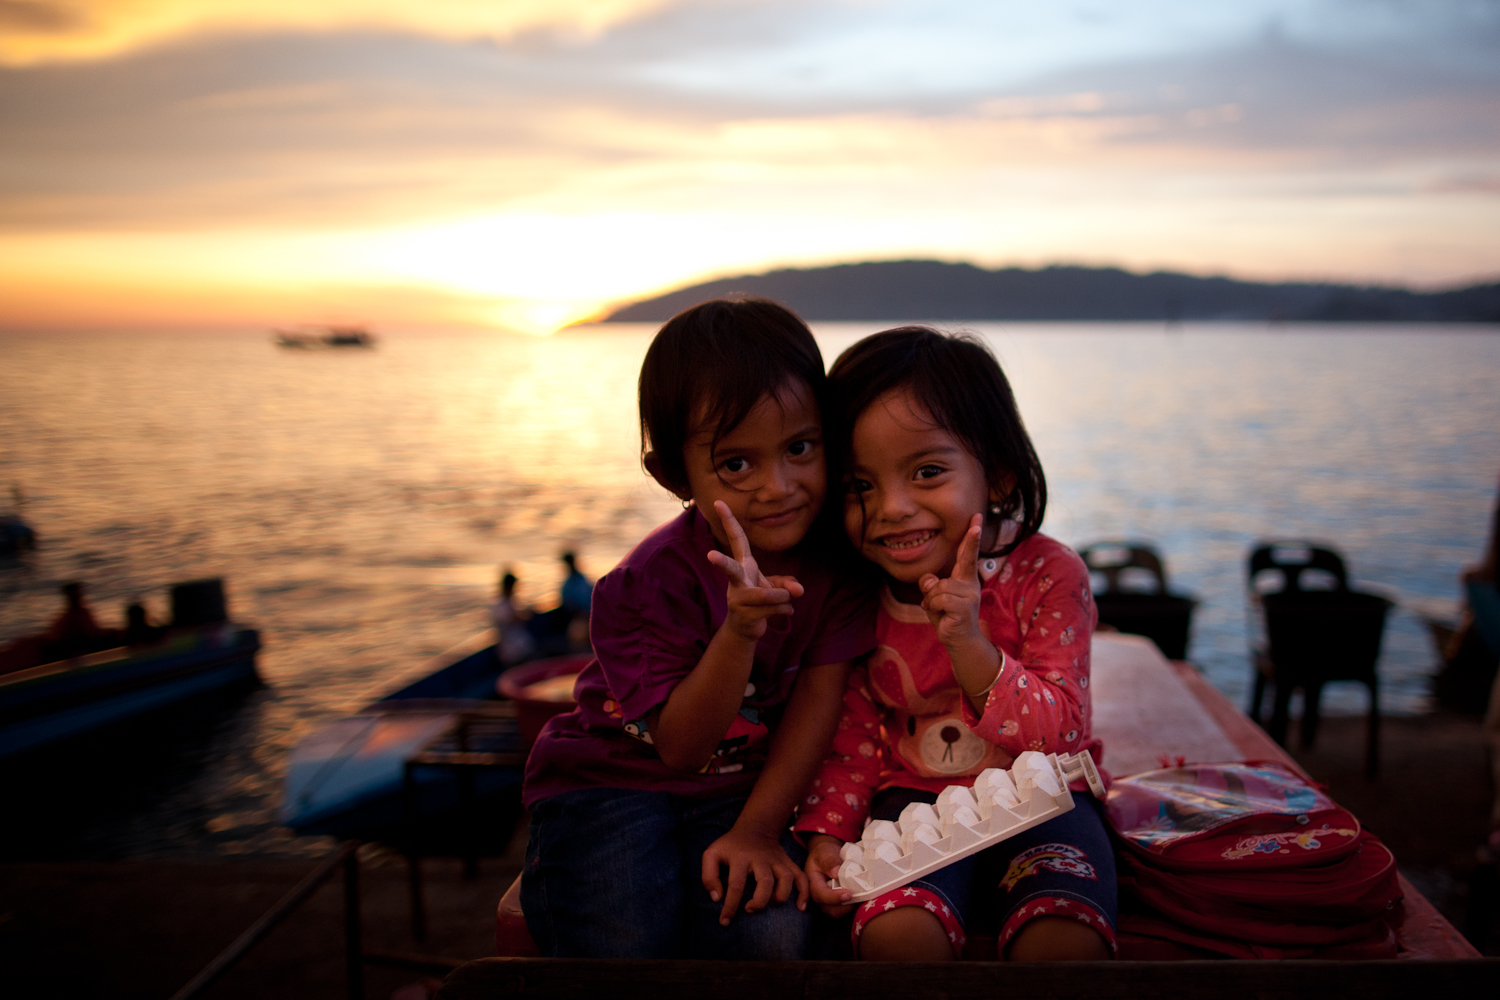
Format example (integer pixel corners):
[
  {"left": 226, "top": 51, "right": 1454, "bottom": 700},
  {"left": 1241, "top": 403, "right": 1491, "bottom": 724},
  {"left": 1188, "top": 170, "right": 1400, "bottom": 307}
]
[{"left": 828, "top": 327, "right": 1047, "bottom": 556}]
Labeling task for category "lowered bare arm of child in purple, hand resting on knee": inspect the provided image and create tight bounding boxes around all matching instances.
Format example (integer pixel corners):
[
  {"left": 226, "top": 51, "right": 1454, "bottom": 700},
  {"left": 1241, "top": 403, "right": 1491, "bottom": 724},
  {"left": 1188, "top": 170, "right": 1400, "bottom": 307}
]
[{"left": 702, "top": 653, "right": 849, "bottom": 924}]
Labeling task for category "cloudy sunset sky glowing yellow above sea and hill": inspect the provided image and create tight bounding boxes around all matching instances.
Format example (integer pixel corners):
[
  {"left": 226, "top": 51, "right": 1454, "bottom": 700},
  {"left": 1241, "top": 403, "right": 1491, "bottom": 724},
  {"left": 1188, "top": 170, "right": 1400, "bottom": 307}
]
[{"left": 0, "top": 0, "right": 1500, "bottom": 331}]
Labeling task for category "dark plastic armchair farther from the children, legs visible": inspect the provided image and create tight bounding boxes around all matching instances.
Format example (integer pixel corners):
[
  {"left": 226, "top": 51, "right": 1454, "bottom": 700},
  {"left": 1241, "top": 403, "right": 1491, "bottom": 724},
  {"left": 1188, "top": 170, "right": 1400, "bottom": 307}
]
[{"left": 1248, "top": 541, "right": 1391, "bottom": 777}]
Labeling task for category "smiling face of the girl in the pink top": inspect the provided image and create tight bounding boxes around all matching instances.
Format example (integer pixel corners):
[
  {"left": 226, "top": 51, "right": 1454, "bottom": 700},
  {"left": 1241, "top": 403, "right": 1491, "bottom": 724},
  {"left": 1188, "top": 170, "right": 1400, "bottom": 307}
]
[{"left": 845, "top": 390, "right": 992, "bottom": 601}]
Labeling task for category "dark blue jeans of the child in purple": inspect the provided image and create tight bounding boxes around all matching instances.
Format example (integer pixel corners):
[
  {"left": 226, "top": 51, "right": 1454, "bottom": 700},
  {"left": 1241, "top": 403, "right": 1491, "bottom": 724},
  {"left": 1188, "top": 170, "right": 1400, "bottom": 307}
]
[{"left": 521, "top": 789, "right": 812, "bottom": 960}]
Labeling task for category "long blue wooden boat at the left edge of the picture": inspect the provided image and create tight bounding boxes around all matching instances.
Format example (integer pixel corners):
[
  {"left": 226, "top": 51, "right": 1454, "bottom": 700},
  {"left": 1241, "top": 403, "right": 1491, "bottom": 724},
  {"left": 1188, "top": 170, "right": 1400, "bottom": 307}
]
[{"left": 0, "top": 622, "right": 261, "bottom": 759}]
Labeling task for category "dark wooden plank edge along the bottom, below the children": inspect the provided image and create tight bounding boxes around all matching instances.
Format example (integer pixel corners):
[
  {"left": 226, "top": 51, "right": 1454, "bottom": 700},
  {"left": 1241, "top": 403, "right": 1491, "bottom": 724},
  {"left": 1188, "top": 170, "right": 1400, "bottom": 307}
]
[{"left": 437, "top": 958, "right": 1500, "bottom": 1000}]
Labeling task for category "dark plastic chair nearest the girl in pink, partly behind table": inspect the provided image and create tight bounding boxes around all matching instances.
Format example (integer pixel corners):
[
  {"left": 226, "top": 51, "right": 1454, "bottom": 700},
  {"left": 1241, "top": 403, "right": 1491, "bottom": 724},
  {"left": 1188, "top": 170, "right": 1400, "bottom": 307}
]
[{"left": 1079, "top": 541, "right": 1197, "bottom": 660}]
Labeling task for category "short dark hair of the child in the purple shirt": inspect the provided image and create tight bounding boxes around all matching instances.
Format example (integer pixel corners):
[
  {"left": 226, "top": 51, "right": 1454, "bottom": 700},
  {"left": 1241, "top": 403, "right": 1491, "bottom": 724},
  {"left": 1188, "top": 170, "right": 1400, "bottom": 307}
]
[{"left": 641, "top": 295, "right": 839, "bottom": 492}]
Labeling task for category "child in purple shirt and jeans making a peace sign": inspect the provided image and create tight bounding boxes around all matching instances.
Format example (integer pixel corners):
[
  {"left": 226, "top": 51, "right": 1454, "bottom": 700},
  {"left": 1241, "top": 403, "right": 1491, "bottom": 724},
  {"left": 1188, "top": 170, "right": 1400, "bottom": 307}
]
[{"left": 522, "top": 298, "right": 875, "bottom": 958}]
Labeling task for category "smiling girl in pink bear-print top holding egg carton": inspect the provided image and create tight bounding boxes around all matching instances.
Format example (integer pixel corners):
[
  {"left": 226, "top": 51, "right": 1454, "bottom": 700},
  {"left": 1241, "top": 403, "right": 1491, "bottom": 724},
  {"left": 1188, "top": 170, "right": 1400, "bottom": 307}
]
[{"left": 797, "top": 327, "right": 1116, "bottom": 961}]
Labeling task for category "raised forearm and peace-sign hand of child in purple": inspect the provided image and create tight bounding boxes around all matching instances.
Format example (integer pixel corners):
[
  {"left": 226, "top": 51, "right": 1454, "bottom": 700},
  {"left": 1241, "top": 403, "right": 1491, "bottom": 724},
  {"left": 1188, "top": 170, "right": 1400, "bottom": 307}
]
[{"left": 651, "top": 501, "right": 803, "bottom": 773}]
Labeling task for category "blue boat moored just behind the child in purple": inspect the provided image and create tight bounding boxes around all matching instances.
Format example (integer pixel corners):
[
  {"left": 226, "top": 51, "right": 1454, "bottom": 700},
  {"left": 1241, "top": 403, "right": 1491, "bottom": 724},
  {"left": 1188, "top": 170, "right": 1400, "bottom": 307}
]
[{"left": 281, "top": 631, "right": 593, "bottom": 843}]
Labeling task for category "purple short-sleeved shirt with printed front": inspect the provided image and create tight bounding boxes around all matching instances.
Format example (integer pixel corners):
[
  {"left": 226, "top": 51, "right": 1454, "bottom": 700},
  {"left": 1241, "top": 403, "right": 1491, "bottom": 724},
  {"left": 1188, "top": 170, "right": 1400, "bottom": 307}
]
[{"left": 524, "top": 508, "right": 875, "bottom": 807}]
